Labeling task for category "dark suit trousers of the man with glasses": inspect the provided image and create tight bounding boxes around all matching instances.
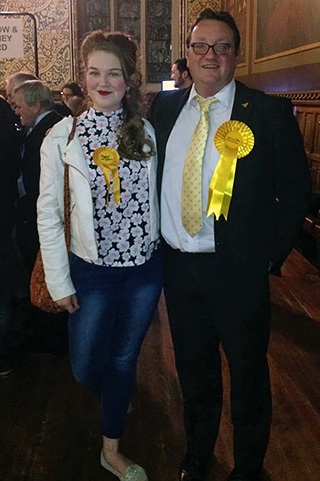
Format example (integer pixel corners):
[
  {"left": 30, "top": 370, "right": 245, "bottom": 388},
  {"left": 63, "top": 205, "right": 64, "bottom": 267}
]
[{"left": 164, "top": 246, "right": 271, "bottom": 476}]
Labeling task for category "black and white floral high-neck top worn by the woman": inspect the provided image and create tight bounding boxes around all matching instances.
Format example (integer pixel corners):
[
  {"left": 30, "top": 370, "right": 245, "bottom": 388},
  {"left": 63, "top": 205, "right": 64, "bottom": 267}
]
[{"left": 76, "top": 108, "right": 157, "bottom": 267}]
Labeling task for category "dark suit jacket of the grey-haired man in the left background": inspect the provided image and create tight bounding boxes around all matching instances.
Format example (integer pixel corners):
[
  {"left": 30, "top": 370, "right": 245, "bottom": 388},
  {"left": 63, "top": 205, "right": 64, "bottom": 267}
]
[{"left": 16, "top": 111, "right": 63, "bottom": 270}]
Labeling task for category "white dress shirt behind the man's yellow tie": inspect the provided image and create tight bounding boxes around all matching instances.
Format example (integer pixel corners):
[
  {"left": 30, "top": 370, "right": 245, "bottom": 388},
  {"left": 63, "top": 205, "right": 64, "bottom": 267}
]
[{"left": 161, "top": 80, "right": 236, "bottom": 252}]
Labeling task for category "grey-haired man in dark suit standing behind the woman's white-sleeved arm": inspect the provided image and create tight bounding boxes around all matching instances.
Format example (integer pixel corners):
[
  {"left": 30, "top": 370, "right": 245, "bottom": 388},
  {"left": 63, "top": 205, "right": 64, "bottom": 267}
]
[{"left": 13, "top": 80, "right": 67, "bottom": 353}]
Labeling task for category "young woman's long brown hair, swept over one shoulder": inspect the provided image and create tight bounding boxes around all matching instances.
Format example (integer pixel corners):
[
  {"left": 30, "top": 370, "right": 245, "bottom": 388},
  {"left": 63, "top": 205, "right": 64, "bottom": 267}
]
[{"left": 81, "top": 30, "right": 154, "bottom": 160}]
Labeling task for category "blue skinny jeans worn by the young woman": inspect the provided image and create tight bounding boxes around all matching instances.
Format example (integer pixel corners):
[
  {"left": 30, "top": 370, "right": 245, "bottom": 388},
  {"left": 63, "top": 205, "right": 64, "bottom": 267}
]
[{"left": 69, "top": 249, "right": 163, "bottom": 439}]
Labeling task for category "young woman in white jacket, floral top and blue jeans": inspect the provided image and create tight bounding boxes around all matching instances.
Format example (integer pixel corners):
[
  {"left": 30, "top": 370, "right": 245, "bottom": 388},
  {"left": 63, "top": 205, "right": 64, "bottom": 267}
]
[{"left": 38, "top": 31, "right": 162, "bottom": 481}]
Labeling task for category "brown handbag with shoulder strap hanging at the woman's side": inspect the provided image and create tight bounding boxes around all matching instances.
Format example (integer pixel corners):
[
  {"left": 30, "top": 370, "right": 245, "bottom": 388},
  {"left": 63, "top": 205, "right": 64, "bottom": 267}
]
[{"left": 30, "top": 118, "right": 77, "bottom": 314}]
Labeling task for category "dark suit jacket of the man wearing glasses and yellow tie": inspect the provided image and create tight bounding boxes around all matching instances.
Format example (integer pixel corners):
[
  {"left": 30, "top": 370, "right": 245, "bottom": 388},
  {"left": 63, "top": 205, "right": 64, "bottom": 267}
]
[{"left": 149, "top": 82, "right": 311, "bottom": 308}]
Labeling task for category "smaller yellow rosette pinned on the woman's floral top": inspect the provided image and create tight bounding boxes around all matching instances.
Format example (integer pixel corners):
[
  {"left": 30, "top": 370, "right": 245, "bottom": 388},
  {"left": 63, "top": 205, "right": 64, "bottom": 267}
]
[{"left": 93, "top": 147, "right": 120, "bottom": 205}]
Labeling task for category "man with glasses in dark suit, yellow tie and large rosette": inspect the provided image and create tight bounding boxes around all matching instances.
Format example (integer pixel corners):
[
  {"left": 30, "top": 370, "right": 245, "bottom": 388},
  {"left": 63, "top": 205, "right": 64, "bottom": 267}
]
[{"left": 150, "top": 9, "right": 310, "bottom": 481}]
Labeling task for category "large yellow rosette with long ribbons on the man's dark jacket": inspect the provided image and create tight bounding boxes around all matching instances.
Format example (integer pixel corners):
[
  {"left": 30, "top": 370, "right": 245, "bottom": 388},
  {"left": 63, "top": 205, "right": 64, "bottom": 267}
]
[{"left": 207, "top": 120, "right": 254, "bottom": 220}]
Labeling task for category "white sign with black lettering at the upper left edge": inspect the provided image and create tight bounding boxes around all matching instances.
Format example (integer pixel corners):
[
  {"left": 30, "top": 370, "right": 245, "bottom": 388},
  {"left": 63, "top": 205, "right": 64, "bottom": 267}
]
[{"left": 0, "top": 16, "right": 23, "bottom": 58}]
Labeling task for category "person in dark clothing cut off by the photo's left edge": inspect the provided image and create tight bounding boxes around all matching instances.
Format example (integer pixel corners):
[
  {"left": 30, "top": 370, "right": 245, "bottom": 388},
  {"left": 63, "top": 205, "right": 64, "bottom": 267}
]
[{"left": 0, "top": 98, "right": 20, "bottom": 378}]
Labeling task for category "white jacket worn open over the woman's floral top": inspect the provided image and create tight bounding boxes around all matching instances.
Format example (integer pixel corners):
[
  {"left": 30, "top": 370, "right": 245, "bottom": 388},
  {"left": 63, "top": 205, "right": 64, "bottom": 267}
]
[{"left": 37, "top": 117, "right": 159, "bottom": 300}]
